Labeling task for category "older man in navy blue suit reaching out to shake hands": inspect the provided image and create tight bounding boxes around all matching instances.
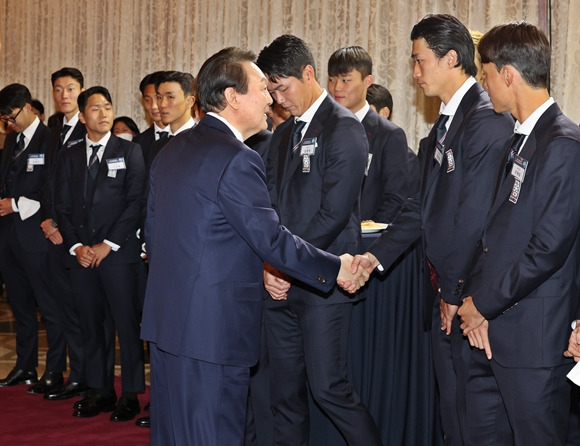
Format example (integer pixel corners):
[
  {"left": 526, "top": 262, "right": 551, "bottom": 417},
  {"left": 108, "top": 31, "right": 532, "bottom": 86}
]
[{"left": 142, "top": 48, "right": 364, "bottom": 446}]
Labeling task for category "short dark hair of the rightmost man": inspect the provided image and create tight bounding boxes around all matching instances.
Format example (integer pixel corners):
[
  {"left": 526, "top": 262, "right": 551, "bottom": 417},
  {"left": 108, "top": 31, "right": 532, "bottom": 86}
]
[{"left": 478, "top": 22, "right": 551, "bottom": 88}]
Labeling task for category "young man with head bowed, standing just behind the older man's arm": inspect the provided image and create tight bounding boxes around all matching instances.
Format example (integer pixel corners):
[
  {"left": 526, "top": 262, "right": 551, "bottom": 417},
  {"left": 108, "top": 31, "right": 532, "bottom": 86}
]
[{"left": 257, "top": 35, "right": 381, "bottom": 445}]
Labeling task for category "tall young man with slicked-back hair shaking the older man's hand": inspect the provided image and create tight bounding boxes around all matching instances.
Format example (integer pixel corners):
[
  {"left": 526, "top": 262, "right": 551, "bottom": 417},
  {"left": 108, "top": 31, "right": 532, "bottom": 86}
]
[{"left": 352, "top": 14, "right": 513, "bottom": 445}]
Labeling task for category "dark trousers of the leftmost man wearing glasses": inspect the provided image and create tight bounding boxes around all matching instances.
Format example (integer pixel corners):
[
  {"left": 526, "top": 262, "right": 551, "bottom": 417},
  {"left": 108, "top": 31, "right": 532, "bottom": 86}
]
[{"left": 0, "top": 226, "right": 66, "bottom": 372}]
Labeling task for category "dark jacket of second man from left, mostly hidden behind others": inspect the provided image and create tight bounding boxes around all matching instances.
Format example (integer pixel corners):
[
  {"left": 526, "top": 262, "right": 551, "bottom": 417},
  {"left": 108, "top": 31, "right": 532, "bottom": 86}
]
[{"left": 41, "top": 121, "right": 87, "bottom": 223}]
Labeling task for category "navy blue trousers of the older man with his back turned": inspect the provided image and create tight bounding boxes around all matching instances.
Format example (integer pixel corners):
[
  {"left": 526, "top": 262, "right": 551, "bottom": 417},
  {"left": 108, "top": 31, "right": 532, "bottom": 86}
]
[{"left": 150, "top": 342, "right": 250, "bottom": 446}]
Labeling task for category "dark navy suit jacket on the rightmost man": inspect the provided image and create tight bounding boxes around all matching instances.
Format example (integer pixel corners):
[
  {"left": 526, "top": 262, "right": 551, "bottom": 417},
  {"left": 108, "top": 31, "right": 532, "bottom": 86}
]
[{"left": 464, "top": 104, "right": 580, "bottom": 367}]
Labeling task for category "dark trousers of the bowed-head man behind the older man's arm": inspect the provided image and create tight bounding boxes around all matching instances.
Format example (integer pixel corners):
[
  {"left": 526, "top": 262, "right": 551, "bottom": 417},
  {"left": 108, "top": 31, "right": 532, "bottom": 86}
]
[{"left": 264, "top": 299, "right": 381, "bottom": 446}]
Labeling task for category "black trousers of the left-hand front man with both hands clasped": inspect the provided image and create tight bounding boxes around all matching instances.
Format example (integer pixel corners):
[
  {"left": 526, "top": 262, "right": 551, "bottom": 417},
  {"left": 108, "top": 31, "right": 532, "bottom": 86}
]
[{"left": 71, "top": 263, "right": 145, "bottom": 392}]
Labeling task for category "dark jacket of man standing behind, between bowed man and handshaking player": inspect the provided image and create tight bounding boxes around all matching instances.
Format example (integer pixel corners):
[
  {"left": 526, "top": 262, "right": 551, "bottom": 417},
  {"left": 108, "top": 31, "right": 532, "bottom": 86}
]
[{"left": 360, "top": 109, "right": 417, "bottom": 223}]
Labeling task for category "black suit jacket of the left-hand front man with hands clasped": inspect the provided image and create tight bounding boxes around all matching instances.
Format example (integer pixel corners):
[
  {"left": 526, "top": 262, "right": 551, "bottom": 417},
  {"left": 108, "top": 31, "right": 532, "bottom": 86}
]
[{"left": 56, "top": 135, "right": 145, "bottom": 267}]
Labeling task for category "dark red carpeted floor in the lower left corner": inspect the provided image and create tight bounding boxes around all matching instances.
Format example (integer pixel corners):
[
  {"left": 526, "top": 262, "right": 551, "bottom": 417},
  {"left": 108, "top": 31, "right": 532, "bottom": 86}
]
[{"left": 0, "top": 377, "right": 149, "bottom": 446}]
